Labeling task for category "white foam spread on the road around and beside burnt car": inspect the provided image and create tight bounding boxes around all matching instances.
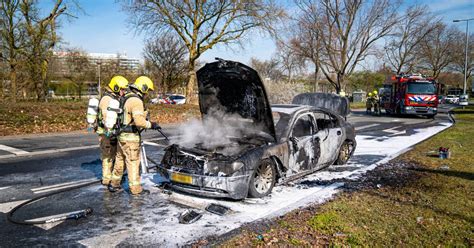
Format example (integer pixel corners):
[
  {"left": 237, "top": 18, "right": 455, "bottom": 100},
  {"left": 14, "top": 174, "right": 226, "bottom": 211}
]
[{"left": 81, "top": 123, "right": 451, "bottom": 246}]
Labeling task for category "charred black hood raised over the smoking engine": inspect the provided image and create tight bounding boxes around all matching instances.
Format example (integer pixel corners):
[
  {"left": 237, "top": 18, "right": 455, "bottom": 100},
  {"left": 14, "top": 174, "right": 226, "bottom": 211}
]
[{"left": 197, "top": 60, "right": 276, "bottom": 141}]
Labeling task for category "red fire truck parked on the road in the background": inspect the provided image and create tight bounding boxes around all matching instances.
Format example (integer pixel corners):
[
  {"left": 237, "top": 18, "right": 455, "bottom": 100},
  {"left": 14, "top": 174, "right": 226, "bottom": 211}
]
[{"left": 379, "top": 74, "right": 438, "bottom": 117}]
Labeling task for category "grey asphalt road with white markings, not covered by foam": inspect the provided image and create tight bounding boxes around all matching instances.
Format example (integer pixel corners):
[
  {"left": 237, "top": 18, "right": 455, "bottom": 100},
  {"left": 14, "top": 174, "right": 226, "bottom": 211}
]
[{"left": 0, "top": 103, "right": 456, "bottom": 247}]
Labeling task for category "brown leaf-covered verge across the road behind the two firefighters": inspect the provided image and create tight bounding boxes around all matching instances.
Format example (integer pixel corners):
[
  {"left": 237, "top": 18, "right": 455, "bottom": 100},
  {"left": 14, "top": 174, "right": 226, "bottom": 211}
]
[{"left": 0, "top": 101, "right": 199, "bottom": 136}]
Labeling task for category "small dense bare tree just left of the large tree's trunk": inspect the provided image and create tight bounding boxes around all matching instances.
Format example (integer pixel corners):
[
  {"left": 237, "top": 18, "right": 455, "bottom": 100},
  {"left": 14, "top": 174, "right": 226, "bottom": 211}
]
[{"left": 143, "top": 36, "right": 187, "bottom": 92}]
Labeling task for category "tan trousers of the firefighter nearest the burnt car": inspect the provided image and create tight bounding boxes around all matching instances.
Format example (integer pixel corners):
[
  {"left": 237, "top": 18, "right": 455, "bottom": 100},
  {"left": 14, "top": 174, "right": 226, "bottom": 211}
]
[{"left": 111, "top": 140, "right": 143, "bottom": 194}]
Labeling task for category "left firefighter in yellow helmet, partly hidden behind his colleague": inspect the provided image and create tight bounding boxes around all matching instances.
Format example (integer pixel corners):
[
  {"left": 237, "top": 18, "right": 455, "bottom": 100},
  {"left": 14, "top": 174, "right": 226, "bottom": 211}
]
[{"left": 96, "top": 76, "right": 128, "bottom": 186}]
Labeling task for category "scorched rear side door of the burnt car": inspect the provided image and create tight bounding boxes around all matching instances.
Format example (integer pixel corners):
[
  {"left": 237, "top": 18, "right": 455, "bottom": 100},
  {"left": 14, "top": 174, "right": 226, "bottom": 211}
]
[{"left": 314, "top": 111, "right": 344, "bottom": 168}]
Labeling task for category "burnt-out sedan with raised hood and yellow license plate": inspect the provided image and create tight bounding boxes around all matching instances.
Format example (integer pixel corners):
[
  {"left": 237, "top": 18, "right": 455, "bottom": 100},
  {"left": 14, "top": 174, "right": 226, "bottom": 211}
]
[{"left": 158, "top": 60, "right": 356, "bottom": 199}]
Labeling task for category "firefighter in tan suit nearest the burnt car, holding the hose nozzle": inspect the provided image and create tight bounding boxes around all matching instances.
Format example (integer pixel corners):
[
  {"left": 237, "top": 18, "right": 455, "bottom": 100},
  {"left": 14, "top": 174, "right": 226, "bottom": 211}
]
[{"left": 109, "top": 76, "right": 161, "bottom": 195}]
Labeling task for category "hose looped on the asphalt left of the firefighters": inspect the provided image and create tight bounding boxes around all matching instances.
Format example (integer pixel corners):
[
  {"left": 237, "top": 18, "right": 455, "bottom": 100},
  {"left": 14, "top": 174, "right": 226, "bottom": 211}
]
[{"left": 7, "top": 180, "right": 101, "bottom": 225}]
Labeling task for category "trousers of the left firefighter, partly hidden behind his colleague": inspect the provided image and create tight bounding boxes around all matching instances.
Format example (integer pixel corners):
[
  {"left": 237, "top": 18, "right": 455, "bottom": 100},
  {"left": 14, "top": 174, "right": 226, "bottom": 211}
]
[{"left": 99, "top": 135, "right": 117, "bottom": 185}]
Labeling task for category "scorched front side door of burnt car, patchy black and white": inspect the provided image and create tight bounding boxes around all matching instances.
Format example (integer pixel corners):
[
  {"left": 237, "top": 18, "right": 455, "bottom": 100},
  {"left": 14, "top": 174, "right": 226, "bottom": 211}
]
[{"left": 287, "top": 113, "right": 319, "bottom": 176}]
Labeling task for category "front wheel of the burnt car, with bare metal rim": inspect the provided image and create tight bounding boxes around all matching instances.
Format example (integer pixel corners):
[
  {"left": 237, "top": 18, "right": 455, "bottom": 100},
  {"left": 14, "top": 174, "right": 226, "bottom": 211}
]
[{"left": 249, "top": 159, "right": 276, "bottom": 198}]
